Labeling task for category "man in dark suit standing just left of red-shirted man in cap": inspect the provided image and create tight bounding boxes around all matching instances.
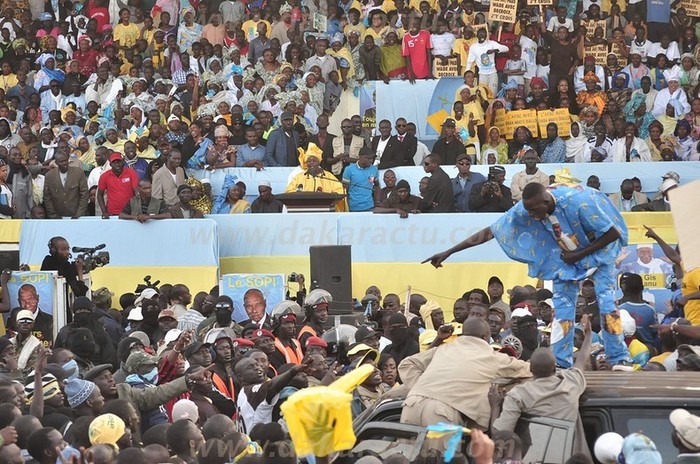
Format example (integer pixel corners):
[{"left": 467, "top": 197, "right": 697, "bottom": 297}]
[{"left": 44, "top": 153, "right": 89, "bottom": 219}]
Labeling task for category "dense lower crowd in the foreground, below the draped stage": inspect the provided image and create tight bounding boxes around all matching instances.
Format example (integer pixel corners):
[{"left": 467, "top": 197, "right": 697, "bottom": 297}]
[{"left": 0, "top": 234, "right": 700, "bottom": 464}]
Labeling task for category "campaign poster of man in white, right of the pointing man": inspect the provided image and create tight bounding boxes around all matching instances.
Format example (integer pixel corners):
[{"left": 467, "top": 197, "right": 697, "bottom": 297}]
[{"left": 615, "top": 243, "right": 680, "bottom": 314}]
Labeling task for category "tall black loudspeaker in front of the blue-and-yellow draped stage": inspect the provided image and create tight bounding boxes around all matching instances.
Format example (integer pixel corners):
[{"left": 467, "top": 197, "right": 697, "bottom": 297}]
[{"left": 309, "top": 245, "right": 352, "bottom": 314}]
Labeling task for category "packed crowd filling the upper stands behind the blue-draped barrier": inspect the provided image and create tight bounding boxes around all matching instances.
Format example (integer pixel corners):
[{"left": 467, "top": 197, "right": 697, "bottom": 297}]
[{"left": 0, "top": 0, "right": 700, "bottom": 216}]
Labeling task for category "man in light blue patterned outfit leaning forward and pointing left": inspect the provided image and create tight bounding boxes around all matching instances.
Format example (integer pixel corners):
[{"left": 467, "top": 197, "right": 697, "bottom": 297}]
[{"left": 423, "top": 183, "right": 630, "bottom": 368}]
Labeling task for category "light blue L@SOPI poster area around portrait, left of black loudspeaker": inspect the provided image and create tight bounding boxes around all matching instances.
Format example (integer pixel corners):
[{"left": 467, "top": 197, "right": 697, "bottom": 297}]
[{"left": 220, "top": 274, "right": 286, "bottom": 322}]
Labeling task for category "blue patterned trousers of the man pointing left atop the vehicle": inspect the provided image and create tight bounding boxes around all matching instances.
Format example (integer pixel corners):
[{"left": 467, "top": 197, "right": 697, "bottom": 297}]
[{"left": 552, "top": 264, "right": 631, "bottom": 368}]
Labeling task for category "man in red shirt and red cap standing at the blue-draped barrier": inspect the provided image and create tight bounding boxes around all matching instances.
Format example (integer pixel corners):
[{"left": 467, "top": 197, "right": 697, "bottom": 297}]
[{"left": 97, "top": 152, "right": 139, "bottom": 219}]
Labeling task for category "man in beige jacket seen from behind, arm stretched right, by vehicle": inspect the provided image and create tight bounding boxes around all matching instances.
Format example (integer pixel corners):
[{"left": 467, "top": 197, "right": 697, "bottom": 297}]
[{"left": 399, "top": 318, "right": 531, "bottom": 436}]
